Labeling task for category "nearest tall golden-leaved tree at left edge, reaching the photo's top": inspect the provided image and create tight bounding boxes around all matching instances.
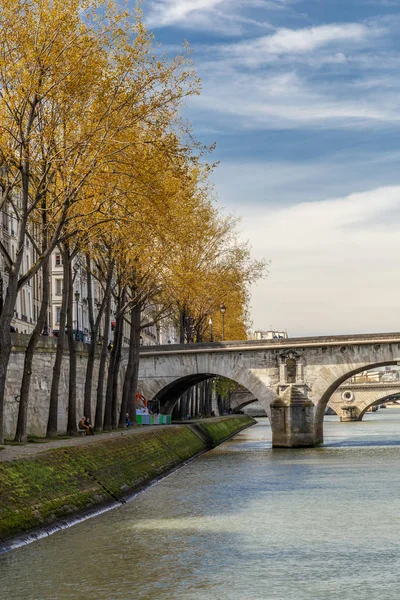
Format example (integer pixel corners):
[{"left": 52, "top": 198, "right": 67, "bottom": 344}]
[{"left": 0, "top": 0, "right": 198, "bottom": 441}]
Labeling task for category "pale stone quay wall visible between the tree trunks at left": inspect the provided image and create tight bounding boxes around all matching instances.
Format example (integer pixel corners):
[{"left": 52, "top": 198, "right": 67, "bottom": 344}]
[{"left": 4, "top": 334, "right": 109, "bottom": 439}]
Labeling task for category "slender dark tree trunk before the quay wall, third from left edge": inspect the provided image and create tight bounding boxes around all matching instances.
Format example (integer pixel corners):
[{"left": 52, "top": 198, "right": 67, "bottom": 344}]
[{"left": 46, "top": 249, "right": 72, "bottom": 438}]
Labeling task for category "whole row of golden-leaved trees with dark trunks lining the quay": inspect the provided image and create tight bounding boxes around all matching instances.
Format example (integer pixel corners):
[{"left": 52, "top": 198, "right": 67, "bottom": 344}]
[{"left": 0, "top": 0, "right": 263, "bottom": 443}]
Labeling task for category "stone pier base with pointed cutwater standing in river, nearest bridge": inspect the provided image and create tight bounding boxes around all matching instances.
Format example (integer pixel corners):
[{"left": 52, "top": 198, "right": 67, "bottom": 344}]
[{"left": 270, "top": 385, "right": 322, "bottom": 448}]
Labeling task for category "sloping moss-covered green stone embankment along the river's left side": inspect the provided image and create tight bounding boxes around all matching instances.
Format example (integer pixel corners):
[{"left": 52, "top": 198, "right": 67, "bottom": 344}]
[{"left": 0, "top": 415, "right": 255, "bottom": 553}]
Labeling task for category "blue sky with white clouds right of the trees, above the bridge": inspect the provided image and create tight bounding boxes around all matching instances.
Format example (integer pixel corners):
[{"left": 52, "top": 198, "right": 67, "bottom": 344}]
[{"left": 144, "top": 0, "right": 400, "bottom": 336}]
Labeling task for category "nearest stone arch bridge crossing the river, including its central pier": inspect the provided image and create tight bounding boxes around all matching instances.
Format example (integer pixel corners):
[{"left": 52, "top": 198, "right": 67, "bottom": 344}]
[{"left": 139, "top": 333, "right": 400, "bottom": 447}]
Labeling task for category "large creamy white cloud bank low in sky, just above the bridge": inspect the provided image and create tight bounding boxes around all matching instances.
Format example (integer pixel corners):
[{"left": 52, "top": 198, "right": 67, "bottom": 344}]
[{"left": 242, "top": 186, "right": 400, "bottom": 335}]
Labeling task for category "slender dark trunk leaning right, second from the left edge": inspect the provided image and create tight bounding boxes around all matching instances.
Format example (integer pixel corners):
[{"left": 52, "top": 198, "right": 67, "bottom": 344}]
[{"left": 14, "top": 259, "right": 50, "bottom": 443}]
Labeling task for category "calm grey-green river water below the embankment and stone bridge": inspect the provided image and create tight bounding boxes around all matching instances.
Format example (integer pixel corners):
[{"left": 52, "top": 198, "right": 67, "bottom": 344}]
[{"left": 0, "top": 409, "right": 400, "bottom": 600}]
